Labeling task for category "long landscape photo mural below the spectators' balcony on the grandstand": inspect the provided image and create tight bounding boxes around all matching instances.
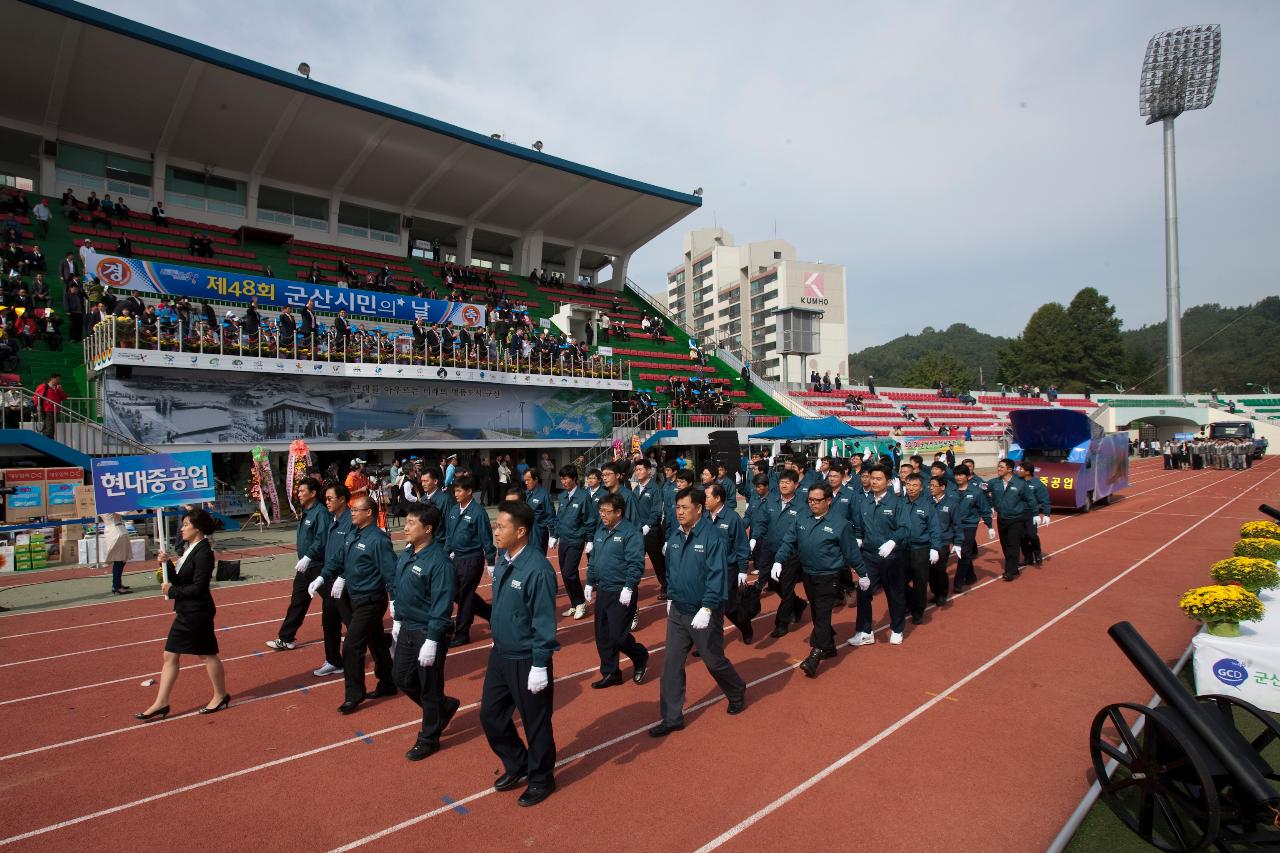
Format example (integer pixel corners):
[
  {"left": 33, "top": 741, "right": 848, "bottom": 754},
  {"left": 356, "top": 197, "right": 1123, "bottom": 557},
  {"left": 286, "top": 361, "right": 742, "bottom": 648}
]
[{"left": 102, "top": 366, "right": 613, "bottom": 444}]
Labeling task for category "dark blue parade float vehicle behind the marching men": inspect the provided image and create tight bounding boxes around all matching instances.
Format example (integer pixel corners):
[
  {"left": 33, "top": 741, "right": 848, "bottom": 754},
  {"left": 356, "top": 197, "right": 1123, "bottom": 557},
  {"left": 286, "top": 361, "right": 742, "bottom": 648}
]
[{"left": 1009, "top": 406, "right": 1129, "bottom": 512}]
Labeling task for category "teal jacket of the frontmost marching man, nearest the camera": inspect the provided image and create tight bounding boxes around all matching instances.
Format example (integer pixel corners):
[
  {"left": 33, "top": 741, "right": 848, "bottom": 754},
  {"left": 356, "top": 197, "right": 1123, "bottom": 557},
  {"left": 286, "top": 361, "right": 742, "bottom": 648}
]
[{"left": 489, "top": 544, "right": 559, "bottom": 666}]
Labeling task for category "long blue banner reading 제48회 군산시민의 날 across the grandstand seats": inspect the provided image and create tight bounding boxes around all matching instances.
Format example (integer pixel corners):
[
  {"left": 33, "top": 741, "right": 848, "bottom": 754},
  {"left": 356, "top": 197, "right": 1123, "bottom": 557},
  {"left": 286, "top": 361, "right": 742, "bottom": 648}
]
[{"left": 86, "top": 252, "right": 485, "bottom": 327}]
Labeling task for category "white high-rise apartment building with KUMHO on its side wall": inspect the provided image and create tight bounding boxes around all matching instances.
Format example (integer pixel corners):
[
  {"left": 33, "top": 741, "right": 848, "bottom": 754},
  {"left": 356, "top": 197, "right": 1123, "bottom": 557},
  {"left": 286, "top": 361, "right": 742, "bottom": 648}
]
[{"left": 667, "top": 228, "right": 849, "bottom": 382}]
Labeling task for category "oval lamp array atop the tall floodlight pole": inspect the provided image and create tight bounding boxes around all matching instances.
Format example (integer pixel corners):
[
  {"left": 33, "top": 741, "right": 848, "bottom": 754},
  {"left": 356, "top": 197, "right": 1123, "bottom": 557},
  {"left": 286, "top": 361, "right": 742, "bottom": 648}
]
[{"left": 1138, "top": 24, "right": 1222, "bottom": 124}]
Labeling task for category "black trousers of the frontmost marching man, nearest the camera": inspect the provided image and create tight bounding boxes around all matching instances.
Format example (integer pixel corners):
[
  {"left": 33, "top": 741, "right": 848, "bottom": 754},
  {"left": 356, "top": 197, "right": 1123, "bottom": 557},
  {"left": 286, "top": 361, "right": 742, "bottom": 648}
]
[{"left": 480, "top": 649, "right": 556, "bottom": 785}]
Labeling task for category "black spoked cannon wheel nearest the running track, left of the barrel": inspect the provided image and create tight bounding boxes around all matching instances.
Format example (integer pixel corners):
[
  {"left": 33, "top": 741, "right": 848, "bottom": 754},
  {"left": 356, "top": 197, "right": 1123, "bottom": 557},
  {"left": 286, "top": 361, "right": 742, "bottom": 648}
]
[{"left": 1089, "top": 702, "right": 1221, "bottom": 853}]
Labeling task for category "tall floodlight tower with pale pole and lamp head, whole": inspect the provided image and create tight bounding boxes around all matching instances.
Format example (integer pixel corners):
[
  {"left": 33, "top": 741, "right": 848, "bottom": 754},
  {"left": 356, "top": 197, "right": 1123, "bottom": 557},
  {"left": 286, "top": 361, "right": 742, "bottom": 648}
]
[{"left": 1138, "top": 24, "right": 1222, "bottom": 396}]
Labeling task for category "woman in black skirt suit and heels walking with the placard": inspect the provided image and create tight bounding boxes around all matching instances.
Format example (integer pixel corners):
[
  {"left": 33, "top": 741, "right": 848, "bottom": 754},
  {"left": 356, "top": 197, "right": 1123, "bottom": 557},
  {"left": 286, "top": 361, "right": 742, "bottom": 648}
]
[{"left": 134, "top": 510, "right": 232, "bottom": 720}]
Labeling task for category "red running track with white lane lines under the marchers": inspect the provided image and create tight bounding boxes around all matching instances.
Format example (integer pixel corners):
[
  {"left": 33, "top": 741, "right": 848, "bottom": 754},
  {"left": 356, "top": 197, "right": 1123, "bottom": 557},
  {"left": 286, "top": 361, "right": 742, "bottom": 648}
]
[{"left": 0, "top": 460, "right": 1280, "bottom": 850}]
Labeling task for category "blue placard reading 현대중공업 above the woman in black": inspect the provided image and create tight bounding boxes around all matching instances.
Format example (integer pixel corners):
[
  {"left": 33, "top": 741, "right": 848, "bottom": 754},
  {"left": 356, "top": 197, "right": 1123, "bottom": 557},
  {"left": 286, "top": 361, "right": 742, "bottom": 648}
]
[{"left": 93, "top": 451, "right": 214, "bottom": 514}]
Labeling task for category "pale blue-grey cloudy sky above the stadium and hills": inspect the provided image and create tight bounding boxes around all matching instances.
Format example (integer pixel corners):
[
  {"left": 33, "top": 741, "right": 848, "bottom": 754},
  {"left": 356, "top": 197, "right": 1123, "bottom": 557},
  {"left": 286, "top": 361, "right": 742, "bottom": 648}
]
[{"left": 92, "top": 0, "right": 1280, "bottom": 350}]
